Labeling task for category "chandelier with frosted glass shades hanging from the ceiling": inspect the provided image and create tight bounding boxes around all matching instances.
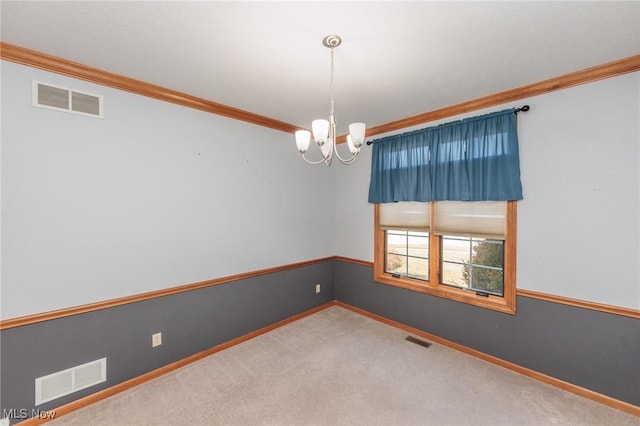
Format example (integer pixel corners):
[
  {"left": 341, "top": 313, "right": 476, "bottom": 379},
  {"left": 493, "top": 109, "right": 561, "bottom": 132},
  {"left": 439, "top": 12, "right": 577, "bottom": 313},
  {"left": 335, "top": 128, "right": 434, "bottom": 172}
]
[{"left": 296, "top": 35, "right": 366, "bottom": 166}]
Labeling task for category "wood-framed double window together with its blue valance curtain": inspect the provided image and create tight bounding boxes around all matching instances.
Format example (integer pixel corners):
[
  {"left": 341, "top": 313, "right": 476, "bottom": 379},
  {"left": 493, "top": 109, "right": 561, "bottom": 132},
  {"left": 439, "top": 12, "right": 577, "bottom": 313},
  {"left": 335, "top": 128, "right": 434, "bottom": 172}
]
[{"left": 369, "top": 109, "right": 522, "bottom": 313}]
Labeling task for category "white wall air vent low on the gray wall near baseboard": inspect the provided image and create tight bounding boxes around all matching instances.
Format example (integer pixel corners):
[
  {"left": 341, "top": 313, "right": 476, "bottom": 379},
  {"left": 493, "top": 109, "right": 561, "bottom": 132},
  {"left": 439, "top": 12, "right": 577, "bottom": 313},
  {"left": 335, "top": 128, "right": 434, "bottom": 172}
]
[{"left": 36, "top": 358, "right": 107, "bottom": 405}]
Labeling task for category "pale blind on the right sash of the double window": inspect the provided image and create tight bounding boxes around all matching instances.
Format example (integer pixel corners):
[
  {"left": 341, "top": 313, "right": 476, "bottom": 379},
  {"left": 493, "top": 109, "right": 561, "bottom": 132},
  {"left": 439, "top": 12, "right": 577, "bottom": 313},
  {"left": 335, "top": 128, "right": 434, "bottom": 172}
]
[{"left": 433, "top": 201, "right": 507, "bottom": 240}]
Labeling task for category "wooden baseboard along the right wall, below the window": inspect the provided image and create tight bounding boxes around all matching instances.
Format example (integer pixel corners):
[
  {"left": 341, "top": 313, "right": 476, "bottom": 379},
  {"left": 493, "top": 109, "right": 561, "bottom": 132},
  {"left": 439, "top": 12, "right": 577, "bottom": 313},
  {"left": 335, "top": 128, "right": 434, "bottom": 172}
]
[{"left": 335, "top": 301, "right": 640, "bottom": 417}]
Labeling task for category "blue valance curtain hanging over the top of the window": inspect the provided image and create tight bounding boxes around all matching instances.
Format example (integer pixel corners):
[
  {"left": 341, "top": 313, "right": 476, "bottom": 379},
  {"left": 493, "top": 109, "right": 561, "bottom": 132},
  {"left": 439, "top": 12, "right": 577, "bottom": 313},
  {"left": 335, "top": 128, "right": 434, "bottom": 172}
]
[{"left": 369, "top": 109, "right": 522, "bottom": 203}]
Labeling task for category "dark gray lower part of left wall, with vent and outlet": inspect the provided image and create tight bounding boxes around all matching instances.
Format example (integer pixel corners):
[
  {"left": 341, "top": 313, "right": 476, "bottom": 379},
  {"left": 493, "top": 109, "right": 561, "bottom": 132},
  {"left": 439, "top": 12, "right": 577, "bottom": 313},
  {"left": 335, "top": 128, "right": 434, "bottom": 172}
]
[{"left": 0, "top": 261, "right": 334, "bottom": 424}]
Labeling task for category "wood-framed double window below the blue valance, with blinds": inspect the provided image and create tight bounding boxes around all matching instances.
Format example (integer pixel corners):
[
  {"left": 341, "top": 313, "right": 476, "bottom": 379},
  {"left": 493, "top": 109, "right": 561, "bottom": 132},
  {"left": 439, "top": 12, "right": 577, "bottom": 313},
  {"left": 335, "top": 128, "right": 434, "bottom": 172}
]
[{"left": 374, "top": 201, "right": 516, "bottom": 314}]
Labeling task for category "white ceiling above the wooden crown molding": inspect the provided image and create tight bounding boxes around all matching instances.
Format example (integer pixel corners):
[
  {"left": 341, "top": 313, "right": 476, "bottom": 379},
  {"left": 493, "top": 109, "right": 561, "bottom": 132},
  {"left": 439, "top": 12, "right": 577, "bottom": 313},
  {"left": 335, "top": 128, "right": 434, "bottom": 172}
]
[{"left": 0, "top": 1, "right": 640, "bottom": 133}]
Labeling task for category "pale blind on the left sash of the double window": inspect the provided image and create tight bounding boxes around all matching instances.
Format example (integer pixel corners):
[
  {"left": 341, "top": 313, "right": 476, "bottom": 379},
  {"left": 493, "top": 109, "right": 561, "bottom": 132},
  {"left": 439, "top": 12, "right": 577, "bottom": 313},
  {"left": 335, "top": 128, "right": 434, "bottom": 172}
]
[{"left": 380, "top": 202, "right": 431, "bottom": 232}]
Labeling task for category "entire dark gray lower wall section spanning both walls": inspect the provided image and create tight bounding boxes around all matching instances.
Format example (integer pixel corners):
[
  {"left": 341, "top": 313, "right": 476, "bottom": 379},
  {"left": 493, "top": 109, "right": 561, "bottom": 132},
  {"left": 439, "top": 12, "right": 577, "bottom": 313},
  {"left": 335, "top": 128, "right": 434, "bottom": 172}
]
[{"left": 0, "top": 260, "right": 640, "bottom": 417}]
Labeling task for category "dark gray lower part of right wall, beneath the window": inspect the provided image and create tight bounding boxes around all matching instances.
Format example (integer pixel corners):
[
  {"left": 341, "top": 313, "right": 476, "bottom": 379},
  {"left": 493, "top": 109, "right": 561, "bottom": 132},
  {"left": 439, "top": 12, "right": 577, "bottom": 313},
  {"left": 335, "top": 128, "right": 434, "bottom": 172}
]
[{"left": 334, "top": 261, "right": 640, "bottom": 406}]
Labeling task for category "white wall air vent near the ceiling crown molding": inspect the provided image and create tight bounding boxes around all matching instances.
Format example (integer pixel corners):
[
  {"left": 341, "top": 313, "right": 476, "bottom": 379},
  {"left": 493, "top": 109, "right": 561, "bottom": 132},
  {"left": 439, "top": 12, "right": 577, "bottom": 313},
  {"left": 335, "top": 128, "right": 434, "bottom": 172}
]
[{"left": 33, "top": 80, "right": 103, "bottom": 118}]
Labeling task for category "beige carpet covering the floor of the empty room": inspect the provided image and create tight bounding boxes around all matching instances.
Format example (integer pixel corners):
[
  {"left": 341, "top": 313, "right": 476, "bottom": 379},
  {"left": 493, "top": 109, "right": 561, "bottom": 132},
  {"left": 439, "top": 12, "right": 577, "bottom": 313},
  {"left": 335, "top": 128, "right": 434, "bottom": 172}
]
[{"left": 50, "top": 307, "right": 640, "bottom": 426}]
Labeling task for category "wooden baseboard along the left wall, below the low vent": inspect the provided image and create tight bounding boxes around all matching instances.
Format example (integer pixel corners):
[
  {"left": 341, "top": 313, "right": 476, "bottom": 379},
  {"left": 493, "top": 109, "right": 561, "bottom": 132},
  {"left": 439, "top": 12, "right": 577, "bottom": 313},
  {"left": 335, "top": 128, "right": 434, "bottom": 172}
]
[{"left": 19, "top": 301, "right": 336, "bottom": 426}]
